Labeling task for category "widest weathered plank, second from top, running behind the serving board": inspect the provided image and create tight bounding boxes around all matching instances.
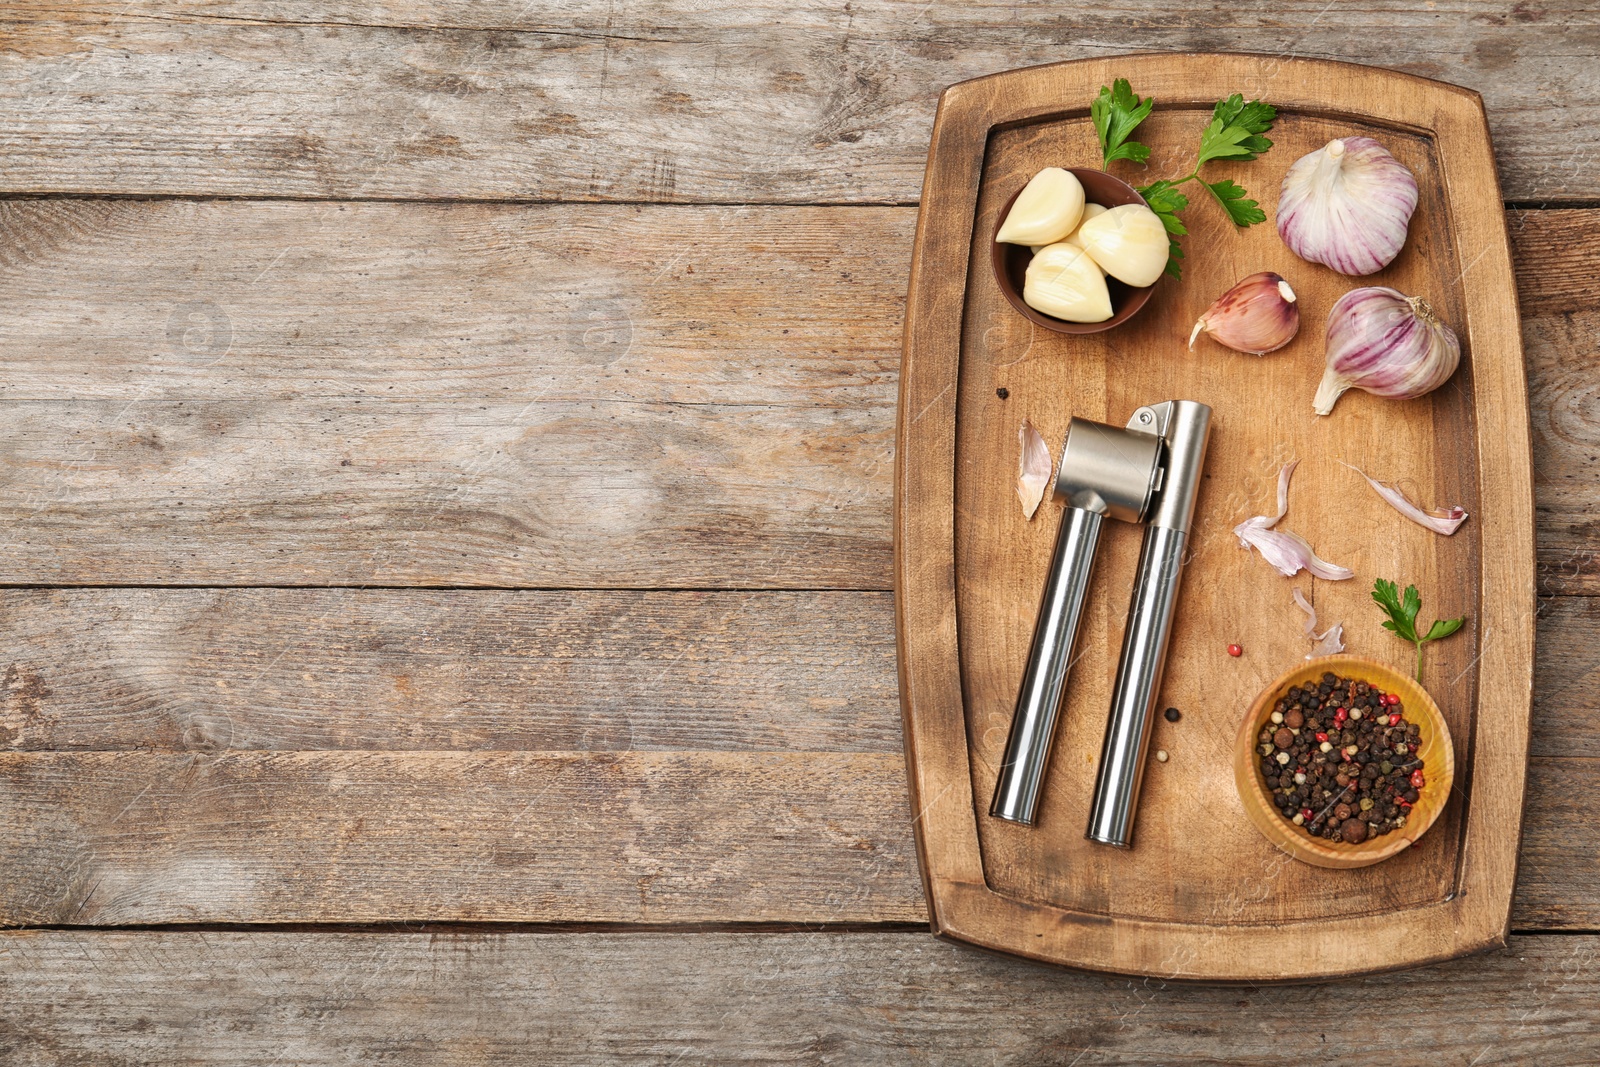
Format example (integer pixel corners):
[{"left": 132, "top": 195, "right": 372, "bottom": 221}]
[{"left": 0, "top": 202, "right": 1600, "bottom": 593}]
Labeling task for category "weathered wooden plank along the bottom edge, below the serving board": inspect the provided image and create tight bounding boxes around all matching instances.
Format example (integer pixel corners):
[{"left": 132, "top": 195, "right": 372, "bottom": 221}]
[{"left": 0, "top": 931, "right": 1600, "bottom": 1067}]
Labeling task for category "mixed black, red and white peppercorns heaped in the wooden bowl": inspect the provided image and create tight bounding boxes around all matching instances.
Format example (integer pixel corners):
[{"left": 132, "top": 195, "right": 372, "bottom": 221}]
[{"left": 1254, "top": 675, "right": 1427, "bottom": 845}]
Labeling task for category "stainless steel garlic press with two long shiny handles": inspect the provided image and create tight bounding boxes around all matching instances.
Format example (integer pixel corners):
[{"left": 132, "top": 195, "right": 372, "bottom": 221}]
[{"left": 989, "top": 400, "right": 1211, "bottom": 848}]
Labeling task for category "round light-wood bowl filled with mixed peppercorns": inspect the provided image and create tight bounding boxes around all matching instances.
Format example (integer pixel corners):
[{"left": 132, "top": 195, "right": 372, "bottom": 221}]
[{"left": 1234, "top": 656, "right": 1456, "bottom": 867}]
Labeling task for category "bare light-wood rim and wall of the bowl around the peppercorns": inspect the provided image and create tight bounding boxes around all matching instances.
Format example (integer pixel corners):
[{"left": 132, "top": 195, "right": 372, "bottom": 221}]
[{"left": 1234, "top": 656, "right": 1456, "bottom": 867}]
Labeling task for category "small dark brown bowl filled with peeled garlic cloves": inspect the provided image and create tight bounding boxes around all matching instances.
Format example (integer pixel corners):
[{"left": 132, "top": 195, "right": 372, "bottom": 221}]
[{"left": 994, "top": 166, "right": 1168, "bottom": 334}]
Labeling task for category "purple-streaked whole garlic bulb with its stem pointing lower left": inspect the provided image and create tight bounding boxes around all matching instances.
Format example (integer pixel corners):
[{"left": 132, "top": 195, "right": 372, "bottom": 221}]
[{"left": 1312, "top": 286, "right": 1461, "bottom": 414}]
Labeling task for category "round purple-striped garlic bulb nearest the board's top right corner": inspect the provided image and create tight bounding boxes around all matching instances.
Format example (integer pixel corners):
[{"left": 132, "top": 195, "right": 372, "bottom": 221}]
[{"left": 1278, "top": 138, "right": 1416, "bottom": 275}]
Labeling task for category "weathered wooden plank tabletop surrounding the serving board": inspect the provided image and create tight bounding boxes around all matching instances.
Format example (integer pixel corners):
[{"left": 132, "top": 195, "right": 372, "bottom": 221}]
[{"left": 0, "top": 0, "right": 1600, "bottom": 1065}]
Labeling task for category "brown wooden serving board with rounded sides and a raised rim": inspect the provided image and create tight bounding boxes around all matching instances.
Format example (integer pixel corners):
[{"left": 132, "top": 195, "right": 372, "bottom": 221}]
[{"left": 894, "top": 54, "right": 1536, "bottom": 982}]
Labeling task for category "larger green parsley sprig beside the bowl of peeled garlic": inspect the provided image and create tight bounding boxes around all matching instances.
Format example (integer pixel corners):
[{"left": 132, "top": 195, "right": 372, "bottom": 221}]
[{"left": 1090, "top": 78, "right": 1278, "bottom": 278}]
